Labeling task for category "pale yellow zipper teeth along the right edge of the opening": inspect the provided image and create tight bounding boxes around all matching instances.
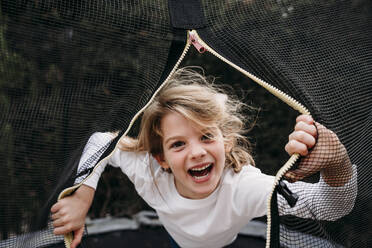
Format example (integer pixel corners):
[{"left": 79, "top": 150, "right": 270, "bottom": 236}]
[{"left": 189, "top": 30, "right": 310, "bottom": 248}]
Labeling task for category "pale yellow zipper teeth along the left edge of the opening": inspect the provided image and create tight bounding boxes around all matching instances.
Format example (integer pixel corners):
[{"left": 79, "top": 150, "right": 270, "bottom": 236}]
[{"left": 58, "top": 34, "right": 191, "bottom": 248}]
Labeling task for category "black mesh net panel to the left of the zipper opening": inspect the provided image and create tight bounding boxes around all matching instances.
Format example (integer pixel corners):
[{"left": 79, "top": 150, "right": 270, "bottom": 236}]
[{"left": 0, "top": 1, "right": 173, "bottom": 247}]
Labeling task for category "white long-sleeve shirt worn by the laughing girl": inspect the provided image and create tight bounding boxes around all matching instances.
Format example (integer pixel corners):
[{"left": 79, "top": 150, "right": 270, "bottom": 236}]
[{"left": 75, "top": 133, "right": 357, "bottom": 247}]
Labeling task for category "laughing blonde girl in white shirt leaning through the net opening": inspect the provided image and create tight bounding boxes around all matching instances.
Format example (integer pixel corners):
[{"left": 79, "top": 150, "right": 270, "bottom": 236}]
[{"left": 51, "top": 69, "right": 356, "bottom": 248}]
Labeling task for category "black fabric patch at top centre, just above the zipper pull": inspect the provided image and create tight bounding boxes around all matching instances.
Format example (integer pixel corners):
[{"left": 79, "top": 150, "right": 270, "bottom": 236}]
[{"left": 168, "top": 0, "right": 206, "bottom": 29}]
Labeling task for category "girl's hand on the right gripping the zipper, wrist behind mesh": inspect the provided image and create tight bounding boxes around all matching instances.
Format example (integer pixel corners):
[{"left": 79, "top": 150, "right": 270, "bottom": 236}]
[{"left": 284, "top": 115, "right": 352, "bottom": 186}]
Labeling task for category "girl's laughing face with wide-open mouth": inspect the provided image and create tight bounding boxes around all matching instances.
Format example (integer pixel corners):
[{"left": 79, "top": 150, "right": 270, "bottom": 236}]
[{"left": 156, "top": 112, "right": 225, "bottom": 199}]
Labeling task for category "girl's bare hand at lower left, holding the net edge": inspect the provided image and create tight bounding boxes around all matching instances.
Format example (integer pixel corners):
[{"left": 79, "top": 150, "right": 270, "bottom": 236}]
[{"left": 51, "top": 185, "right": 95, "bottom": 248}]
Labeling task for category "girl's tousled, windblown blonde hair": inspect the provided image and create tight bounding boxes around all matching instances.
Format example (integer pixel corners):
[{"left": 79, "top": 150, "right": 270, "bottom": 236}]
[{"left": 120, "top": 68, "right": 254, "bottom": 172}]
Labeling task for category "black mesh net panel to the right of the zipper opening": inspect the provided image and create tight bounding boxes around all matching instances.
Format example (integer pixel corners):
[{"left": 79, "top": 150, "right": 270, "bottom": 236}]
[{"left": 199, "top": 1, "right": 372, "bottom": 247}]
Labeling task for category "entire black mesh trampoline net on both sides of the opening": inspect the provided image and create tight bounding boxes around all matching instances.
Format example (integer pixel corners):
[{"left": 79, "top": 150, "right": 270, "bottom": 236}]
[{"left": 0, "top": 0, "right": 372, "bottom": 247}]
